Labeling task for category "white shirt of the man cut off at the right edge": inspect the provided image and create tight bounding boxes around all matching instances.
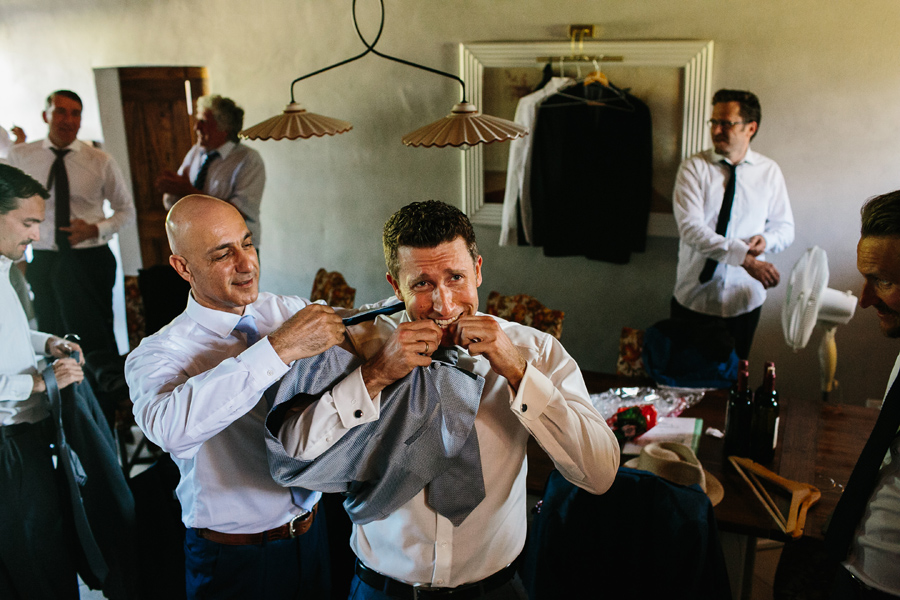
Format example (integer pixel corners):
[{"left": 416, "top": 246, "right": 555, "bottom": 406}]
[{"left": 844, "top": 356, "right": 900, "bottom": 596}]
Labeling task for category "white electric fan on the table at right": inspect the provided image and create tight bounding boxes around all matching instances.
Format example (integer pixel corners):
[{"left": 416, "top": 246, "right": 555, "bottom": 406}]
[{"left": 781, "top": 246, "right": 856, "bottom": 400}]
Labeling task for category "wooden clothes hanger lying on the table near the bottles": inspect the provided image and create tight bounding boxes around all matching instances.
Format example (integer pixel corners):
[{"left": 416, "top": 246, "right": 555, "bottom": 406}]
[{"left": 728, "top": 456, "right": 822, "bottom": 538}]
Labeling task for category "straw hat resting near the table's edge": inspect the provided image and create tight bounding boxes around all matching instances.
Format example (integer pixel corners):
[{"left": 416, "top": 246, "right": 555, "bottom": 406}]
[{"left": 625, "top": 442, "right": 725, "bottom": 506}]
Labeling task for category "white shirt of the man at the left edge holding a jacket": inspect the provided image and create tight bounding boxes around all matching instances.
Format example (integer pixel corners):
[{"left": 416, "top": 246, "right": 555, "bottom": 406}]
[{"left": 0, "top": 256, "right": 53, "bottom": 426}]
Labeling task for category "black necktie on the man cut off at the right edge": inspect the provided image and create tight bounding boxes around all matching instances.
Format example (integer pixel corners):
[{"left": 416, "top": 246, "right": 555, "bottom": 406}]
[{"left": 825, "top": 378, "right": 900, "bottom": 561}]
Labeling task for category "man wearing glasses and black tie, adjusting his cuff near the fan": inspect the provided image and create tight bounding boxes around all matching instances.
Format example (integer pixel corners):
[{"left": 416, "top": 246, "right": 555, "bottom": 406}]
[{"left": 672, "top": 90, "right": 794, "bottom": 358}]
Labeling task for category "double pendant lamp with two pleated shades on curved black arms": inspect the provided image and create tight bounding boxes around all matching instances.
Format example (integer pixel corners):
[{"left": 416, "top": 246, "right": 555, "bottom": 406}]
[{"left": 239, "top": 0, "right": 528, "bottom": 148}]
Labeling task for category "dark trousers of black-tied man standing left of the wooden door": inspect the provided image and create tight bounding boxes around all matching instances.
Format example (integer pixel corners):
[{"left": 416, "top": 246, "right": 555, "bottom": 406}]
[{"left": 25, "top": 246, "right": 118, "bottom": 354}]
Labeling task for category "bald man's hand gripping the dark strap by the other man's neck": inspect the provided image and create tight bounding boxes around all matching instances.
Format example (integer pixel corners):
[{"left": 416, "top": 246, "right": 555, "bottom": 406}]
[{"left": 269, "top": 304, "right": 344, "bottom": 365}]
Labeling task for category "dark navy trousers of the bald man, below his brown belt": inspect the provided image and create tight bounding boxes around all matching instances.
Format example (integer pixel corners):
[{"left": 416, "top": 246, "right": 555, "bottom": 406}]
[{"left": 184, "top": 511, "right": 331, "bottom": 600}]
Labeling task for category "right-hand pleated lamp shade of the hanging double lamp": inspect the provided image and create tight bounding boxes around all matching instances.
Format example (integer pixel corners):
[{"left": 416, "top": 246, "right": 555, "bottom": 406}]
[{"left": 403, "top": 102, "right": 528, "bottom": 148}]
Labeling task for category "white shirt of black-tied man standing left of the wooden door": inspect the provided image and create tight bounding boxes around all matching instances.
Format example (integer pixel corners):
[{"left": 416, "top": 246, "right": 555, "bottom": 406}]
[{"left": 9, "top": 139, "right": 135, "bottom": 250}]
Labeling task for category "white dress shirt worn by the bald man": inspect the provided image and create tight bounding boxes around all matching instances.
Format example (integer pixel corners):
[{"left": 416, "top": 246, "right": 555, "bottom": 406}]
[{"left": 125, "top": 293, "right": 321, "bottom": 533}]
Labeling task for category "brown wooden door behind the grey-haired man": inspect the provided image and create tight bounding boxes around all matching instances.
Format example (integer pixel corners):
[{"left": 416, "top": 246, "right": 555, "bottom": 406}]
[{"left": 118, "top": 67, "right": 208, "bottom": 268}]
